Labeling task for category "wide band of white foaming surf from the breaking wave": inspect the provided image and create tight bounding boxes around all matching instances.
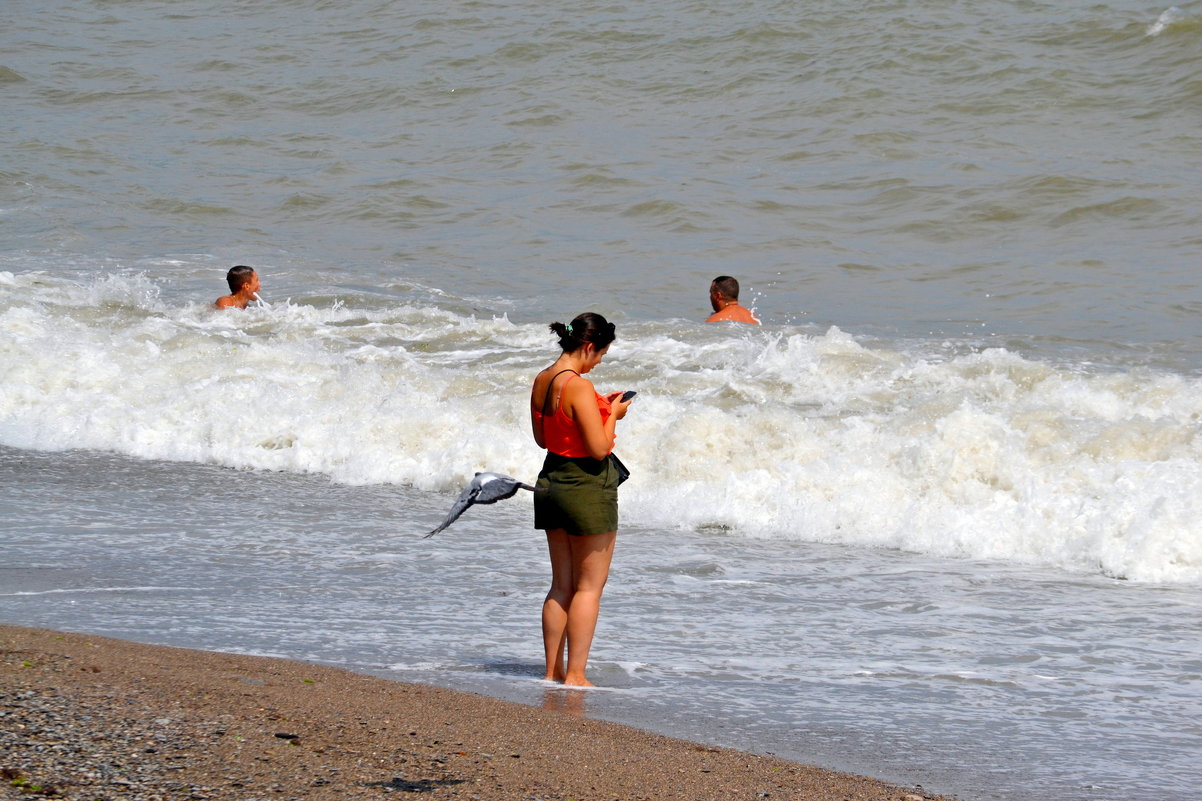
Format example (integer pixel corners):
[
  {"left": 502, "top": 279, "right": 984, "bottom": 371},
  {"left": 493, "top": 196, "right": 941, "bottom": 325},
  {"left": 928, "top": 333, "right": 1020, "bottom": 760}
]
[{"left": 7, "top": 273, "right": 1202, "bottom": 582}]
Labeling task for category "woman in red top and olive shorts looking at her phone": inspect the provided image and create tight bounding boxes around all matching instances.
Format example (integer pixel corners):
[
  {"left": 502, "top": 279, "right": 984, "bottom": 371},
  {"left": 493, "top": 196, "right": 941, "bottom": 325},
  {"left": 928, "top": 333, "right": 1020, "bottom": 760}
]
[{"left": 530, "top": 313, "right": 630, "bottom": 687}]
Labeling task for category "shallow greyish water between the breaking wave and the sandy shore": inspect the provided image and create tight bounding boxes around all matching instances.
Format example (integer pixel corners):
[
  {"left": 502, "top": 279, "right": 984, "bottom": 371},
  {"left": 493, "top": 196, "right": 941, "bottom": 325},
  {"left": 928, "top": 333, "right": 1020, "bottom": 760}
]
[{"left": 0, "top": 442, "right": 1202, "bottom": 799}]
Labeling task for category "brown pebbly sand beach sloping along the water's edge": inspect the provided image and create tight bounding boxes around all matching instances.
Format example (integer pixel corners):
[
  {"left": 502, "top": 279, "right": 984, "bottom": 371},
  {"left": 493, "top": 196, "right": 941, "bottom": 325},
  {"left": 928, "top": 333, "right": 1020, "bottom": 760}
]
[{"left": 0, "top": 625, "right": 951, "bottom": 801}]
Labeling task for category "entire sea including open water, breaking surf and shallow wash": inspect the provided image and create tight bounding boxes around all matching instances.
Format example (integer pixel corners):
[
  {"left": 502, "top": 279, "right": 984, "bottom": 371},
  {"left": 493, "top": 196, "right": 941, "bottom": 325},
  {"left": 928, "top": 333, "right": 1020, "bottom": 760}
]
[{"left": 0, "top": 0, "right": 1202, "bottom": 801}]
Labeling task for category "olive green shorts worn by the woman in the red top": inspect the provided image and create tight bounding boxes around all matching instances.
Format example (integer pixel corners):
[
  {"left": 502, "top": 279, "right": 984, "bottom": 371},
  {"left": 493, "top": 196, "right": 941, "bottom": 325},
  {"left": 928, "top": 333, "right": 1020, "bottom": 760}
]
[{"left": 534, "top": 452, "right": 618, "bottom": 536}]
